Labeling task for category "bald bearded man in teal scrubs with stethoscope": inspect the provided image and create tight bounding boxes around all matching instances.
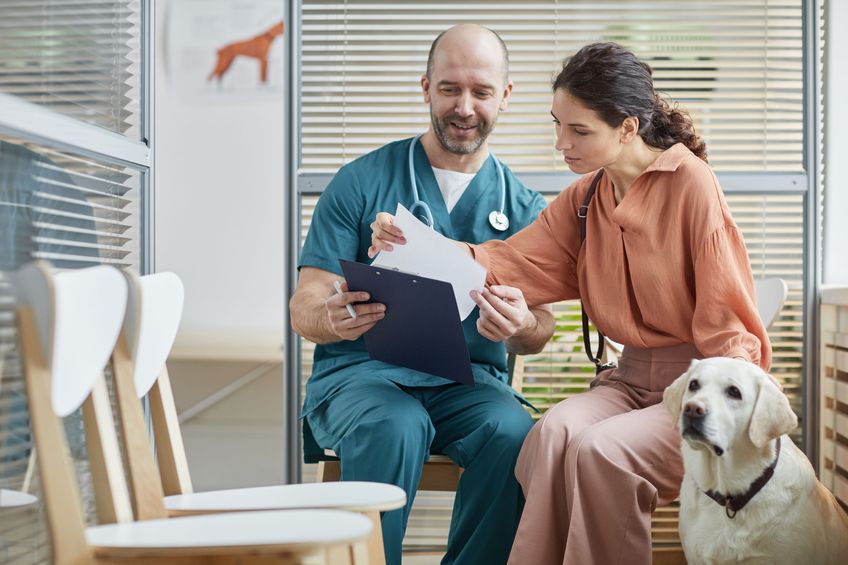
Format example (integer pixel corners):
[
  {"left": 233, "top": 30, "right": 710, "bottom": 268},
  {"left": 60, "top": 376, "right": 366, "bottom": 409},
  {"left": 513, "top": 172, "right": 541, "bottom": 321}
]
[{"left": 291, "top": 25, "right": 554, "bottom": 565}]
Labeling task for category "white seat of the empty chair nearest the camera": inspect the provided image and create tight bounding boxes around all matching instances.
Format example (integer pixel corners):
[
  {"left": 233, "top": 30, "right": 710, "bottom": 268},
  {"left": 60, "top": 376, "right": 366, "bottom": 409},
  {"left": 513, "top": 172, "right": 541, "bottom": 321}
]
[{"left": 85, "top": 510, "right": 372, "bottom": 554}]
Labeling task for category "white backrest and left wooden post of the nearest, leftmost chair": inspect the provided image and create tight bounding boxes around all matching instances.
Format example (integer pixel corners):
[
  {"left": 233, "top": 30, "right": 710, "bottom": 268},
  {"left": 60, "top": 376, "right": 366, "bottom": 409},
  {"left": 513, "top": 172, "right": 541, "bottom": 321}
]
[{"left": 15, "top": 262, "right": 127, "bottom": 564}]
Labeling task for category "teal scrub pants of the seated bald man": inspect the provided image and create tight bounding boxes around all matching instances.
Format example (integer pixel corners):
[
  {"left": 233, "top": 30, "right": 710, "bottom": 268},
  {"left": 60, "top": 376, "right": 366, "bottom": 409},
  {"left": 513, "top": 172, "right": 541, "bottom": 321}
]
[{"left": 307, "top": 374, "right": 533, "bottom": 565}]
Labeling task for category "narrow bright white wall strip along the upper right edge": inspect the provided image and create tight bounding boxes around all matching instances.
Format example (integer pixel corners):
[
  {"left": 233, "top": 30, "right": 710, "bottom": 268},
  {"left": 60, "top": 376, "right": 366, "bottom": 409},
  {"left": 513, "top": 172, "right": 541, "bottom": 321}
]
[{"left": 822, "top": 0, "right": 848, "bottom": 285}]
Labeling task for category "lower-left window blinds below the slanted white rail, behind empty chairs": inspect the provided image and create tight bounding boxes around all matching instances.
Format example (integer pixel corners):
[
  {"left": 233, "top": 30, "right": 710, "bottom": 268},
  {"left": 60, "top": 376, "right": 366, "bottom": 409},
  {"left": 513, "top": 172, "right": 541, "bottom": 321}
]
[{"left": 0, "top": 134, "right": 141, "bottom": 563}]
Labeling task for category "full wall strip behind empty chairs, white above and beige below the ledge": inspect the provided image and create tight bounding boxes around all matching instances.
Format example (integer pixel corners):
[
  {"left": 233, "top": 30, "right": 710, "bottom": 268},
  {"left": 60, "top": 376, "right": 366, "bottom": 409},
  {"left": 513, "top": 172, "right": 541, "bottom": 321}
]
[{"left": 154, "top": 0, "right": 289, "bottom": 490}]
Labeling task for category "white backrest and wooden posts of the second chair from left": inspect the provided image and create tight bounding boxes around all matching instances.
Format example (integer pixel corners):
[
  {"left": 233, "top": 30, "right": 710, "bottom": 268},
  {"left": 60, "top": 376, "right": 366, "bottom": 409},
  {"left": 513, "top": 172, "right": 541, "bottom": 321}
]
[{"left": 112, "top": 271, "right": 191, "bottom": 520}]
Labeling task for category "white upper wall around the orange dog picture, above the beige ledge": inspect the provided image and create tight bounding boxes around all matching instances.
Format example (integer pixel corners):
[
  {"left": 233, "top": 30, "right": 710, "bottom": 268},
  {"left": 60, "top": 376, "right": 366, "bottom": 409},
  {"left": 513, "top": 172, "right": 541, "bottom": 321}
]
[{"left": 155, "top": 0, "right": 289, "bottom": 359}]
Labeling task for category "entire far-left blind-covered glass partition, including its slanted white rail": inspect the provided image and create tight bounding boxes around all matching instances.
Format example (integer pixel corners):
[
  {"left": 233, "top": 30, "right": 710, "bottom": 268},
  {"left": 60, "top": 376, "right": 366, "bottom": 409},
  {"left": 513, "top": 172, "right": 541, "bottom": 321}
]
[{"left": 0, "top": 0, "right": 145, "bottom": 565}]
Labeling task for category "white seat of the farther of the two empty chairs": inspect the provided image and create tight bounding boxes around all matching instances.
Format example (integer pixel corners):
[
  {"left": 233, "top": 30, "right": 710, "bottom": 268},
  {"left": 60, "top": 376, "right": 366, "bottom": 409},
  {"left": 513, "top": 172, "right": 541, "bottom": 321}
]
[{"left": 165, "top": 481, "right": 406, "bottom": 513}]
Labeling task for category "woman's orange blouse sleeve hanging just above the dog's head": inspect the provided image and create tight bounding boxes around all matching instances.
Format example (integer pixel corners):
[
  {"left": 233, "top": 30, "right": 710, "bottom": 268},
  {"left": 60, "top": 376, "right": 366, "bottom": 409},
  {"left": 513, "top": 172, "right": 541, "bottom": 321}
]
[{"left": 692, "top": 223, "right": 771, "bottom": 370}]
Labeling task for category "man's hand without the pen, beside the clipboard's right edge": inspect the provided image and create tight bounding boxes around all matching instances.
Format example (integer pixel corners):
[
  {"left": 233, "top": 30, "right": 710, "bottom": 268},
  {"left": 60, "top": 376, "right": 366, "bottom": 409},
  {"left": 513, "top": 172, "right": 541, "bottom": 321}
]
[{"left": 471, "top": 285, "right": 536, "bottom": 341}]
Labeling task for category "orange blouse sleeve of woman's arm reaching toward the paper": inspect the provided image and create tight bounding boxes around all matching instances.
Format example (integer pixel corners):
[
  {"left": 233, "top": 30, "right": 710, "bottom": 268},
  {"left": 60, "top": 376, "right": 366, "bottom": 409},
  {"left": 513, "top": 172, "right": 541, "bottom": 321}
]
[{"left": 470, "top": 181, "right": 585, "bottom": 307}]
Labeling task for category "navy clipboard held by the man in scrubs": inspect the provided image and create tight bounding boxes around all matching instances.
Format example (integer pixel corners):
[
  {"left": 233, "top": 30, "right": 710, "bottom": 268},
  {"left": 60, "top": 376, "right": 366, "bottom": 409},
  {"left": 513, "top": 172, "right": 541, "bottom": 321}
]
[{"left": 339, "top": 259, "right": 474, "bottom": 386}]
